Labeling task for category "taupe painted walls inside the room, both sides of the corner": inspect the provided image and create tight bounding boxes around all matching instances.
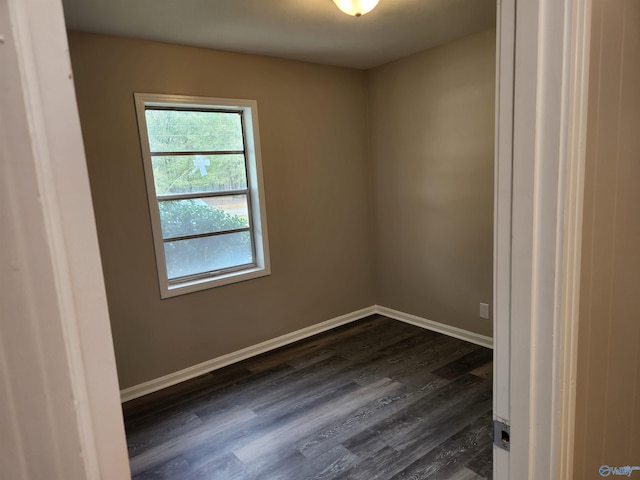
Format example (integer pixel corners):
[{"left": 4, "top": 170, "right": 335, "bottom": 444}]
[{"left": 69, "top": 31, "right": 495, "bottom": 388}]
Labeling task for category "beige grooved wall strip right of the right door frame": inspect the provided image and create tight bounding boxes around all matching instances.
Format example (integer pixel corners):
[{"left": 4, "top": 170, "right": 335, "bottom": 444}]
[{"left": 574, "top": 0, "right": 640, "bottom": 479}]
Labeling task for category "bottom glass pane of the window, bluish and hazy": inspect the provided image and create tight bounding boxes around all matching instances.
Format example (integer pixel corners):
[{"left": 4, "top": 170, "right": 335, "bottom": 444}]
[{"left": 164, "top": 232, "right": 253, "bottom": 280}]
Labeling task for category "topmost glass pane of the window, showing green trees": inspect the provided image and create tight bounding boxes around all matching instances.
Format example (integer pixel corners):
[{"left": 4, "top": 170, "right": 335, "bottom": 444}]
[{"left": 145, "top": 109, "right": 243, "bottom": 153}]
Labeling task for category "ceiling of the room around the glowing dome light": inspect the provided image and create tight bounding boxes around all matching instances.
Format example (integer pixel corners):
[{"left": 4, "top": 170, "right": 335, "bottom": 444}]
[{"left": 63, "top": 0, "right": 496, "bottom": 69}]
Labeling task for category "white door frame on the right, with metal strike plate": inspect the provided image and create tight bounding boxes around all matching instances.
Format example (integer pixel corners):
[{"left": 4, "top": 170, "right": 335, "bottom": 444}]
[{"left": 494, "top": 0, "right": 591, "bottom": 480}]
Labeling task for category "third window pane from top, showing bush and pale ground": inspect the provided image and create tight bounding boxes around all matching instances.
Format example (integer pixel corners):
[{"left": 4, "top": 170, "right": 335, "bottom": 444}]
[{"left": 158, "top": 195, "right": 249, "bottom": 239}]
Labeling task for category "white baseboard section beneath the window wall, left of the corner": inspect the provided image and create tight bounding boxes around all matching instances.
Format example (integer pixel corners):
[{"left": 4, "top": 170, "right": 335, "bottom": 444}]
[{"left": 120, "top": 306, "right": 376, "bottom": 403}]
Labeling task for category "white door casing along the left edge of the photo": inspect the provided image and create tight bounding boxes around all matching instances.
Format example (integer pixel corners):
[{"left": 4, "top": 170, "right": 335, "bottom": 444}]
[{"left": 0, "top": 0, "right": 130, "bottom": 480}]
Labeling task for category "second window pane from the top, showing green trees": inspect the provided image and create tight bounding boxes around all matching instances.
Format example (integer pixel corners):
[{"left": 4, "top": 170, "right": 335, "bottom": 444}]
[{"left": 151, "top": 155, "right": 247, "bottom": 196}]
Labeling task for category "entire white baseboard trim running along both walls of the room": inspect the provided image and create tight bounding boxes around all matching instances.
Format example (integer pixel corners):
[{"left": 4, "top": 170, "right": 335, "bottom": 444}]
[{"left": 120, "top": 305, "right": 493, "bottom": 403}]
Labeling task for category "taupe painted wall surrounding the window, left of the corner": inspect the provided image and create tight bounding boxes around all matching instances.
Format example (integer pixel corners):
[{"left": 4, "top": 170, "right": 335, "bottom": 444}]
[{"left": 69, "top": 32, "right": 375, "bottom": 388}]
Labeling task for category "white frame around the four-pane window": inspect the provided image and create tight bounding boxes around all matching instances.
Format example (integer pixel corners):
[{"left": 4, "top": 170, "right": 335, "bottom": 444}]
[{"left": 134, "top": 93, "right": 271, "bottom": 298}]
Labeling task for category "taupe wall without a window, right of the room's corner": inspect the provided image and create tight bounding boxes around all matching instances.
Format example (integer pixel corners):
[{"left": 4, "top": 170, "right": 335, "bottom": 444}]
[{"left": 369, "top": 30, "right": 496, "bottom": 335}]
